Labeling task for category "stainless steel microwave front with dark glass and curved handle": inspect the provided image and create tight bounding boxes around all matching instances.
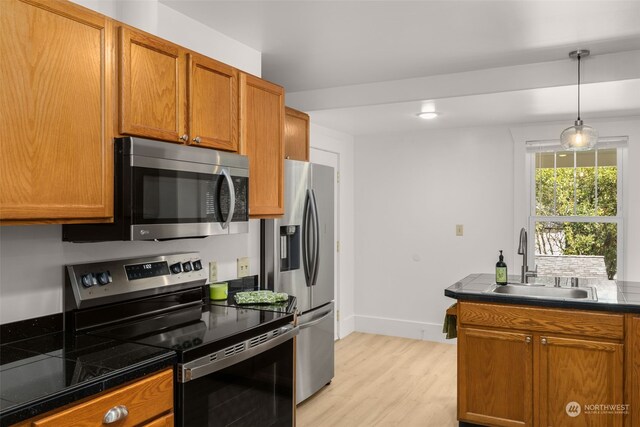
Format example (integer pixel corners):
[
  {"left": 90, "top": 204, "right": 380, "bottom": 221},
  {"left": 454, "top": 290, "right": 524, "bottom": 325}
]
[{"left": 128, "top": 156, "right": 248, "bottom": 240}]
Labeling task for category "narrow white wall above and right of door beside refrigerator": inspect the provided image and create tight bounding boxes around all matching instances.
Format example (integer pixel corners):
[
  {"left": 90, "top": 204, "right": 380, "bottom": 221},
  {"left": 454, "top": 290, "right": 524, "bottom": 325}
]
[{"left": 310, "top": 125, "right": 355, "bottom": 338}]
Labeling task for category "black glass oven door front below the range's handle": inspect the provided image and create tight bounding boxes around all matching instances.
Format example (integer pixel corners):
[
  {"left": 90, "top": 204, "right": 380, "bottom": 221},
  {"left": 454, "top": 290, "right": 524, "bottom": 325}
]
[{"left": 178, "top": 339, "right": 294, "bottom": 427}]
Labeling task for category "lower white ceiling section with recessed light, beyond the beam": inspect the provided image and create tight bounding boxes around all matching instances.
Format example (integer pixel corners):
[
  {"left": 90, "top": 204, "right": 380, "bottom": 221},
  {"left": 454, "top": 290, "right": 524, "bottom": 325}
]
[{"left": 311, "top": 79, "right": 640, "bottom": 135}]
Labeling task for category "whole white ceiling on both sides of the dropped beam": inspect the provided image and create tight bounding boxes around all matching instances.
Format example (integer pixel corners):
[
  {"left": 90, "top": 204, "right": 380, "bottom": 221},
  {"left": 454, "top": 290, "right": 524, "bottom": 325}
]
[{"left": 160, "top": 0, "right": 640, "bottom": 135}]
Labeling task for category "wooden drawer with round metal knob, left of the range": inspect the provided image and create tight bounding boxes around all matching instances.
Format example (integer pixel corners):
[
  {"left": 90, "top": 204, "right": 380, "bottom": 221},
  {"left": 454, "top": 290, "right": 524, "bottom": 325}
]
[{"left": 14, "top": 369, "right": 173, "bottom": 427}]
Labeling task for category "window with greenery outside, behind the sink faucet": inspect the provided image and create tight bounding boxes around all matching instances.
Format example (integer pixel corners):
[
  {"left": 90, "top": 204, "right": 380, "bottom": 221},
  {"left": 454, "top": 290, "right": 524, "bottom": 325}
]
[{"left": 529, "top": 145, "right": 623, "bottom": 279}]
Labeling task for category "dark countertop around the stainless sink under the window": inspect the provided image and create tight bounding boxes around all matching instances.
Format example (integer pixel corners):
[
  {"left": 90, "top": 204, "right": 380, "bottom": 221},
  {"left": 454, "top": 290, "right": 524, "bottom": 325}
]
[{"left": 444, "top": 274, "right": 640, "bottom": 313}]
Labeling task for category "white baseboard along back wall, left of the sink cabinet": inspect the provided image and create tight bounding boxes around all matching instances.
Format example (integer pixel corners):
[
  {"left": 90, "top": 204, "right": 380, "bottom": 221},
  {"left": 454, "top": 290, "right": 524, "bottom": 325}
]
[{"left": 355, "top": 315, "right": 457, "bottom": 344}]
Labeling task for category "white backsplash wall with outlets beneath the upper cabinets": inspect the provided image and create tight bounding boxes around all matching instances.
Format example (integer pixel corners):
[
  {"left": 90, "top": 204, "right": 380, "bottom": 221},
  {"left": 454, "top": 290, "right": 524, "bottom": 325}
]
[{"left": 0, "top": 220, "right": 260, "bottom": 323}]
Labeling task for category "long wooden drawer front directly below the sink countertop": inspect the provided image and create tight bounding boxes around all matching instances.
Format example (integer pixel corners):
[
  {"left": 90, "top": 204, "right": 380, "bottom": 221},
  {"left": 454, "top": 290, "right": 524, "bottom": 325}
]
[{"left": 459, "top": 301, "right": 624, "bottom": 340}]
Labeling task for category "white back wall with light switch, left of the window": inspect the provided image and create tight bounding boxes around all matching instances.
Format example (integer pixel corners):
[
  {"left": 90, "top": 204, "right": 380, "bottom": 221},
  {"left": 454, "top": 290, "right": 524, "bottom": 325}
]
[{"left": 355, "top": 128, "right": 515, "bottom": 341}]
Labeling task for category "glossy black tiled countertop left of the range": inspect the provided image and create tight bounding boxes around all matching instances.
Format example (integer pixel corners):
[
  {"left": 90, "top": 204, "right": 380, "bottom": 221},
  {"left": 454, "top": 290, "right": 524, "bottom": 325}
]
[{"left": 0, "top": 315, "right": 175, "bottom": 427}]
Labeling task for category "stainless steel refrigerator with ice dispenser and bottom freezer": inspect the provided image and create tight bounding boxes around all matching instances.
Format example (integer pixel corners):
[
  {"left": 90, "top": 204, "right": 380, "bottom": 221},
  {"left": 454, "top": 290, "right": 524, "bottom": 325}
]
[{"left": 261, "top": 160, "right": 335, "bottom": 403}]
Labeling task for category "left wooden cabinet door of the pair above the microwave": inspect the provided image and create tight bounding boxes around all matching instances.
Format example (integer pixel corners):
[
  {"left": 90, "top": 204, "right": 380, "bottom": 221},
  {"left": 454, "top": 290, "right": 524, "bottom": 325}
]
[{"left": 119, "top": 27, "right": 186, "bottom": 142}]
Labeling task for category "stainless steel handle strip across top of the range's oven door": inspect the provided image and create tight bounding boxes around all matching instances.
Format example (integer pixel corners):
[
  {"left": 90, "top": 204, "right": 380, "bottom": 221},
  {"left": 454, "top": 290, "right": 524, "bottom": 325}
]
[{"left": 178, "top": 325, "right": 299, "bottom": 383}]
